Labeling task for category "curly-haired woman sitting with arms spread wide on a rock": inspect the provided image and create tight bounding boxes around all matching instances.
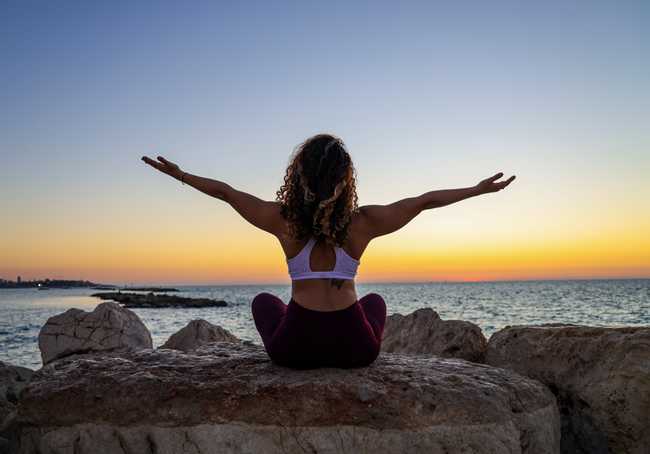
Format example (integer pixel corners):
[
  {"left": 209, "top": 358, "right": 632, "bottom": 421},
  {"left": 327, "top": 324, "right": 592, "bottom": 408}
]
[{"left": 142, "top": 134, "right": 515, "bottom": 368}]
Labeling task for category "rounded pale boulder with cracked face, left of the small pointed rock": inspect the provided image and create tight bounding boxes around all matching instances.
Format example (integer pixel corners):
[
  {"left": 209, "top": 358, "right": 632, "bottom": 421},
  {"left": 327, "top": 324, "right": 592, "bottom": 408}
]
[{"left": 38, "top": 302, "right": 152, "bottom": 364}]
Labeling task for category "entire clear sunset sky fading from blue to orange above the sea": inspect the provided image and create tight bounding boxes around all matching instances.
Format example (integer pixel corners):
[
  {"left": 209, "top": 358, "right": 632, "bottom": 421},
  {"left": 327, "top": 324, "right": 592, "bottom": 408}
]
[{"left": 0, "top": 1, "right": 650, "bottom": 284}]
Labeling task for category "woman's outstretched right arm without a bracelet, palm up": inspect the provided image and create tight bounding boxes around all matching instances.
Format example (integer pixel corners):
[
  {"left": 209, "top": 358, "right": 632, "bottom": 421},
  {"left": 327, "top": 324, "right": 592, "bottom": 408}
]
[{"left": 359, "top": 172, "right": 515, "bottom": 240}]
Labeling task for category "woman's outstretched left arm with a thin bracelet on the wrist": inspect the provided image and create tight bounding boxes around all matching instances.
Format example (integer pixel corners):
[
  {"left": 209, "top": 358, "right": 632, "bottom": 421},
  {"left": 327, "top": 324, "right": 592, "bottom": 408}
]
[{"left": 142, "top": 156, "right": 284, "bottom": 236}]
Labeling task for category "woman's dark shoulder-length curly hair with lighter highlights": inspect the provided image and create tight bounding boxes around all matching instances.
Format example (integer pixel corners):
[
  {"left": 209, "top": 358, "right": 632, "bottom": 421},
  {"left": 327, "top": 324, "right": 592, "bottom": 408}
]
[{"left": 276, "top": 134, "right": 358, "bottom": 246}]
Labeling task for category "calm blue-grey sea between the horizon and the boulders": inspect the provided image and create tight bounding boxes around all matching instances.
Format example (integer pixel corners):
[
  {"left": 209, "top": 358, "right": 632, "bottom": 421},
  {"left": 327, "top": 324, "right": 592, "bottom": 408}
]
[{"left": 0, "top": 279, "right": 650, "bottom": 368}]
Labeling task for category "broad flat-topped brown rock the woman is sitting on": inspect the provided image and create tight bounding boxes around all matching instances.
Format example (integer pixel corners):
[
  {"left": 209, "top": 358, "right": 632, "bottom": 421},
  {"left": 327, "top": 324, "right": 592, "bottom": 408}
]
[{"left": 12, "top": 343, "right": 560, "bottom": 454}]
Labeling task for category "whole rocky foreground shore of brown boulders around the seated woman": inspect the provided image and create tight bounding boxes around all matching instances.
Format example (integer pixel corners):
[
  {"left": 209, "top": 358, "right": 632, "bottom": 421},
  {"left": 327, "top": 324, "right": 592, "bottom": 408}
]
[{"left": 0, "top": 302, "right": 650, "bottom": 454}]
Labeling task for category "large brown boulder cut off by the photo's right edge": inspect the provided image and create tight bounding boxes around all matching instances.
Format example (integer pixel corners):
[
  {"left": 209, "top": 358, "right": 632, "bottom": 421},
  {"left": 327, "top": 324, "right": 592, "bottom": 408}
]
[{"left": 486, "top": 325, "right": 650, "bottom": 454}]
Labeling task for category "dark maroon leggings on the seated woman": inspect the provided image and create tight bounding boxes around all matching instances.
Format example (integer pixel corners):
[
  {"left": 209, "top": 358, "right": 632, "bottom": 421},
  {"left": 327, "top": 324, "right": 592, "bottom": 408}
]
[{"left": 252, "top": 292, "right": 386, "bottom": 369}]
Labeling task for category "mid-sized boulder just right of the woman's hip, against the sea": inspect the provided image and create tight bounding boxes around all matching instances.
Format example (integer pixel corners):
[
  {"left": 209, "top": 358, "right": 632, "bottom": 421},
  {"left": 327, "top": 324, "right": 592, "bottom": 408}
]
[{"left": 381, "top": 308, "right": 487, "bottom": 362}]
